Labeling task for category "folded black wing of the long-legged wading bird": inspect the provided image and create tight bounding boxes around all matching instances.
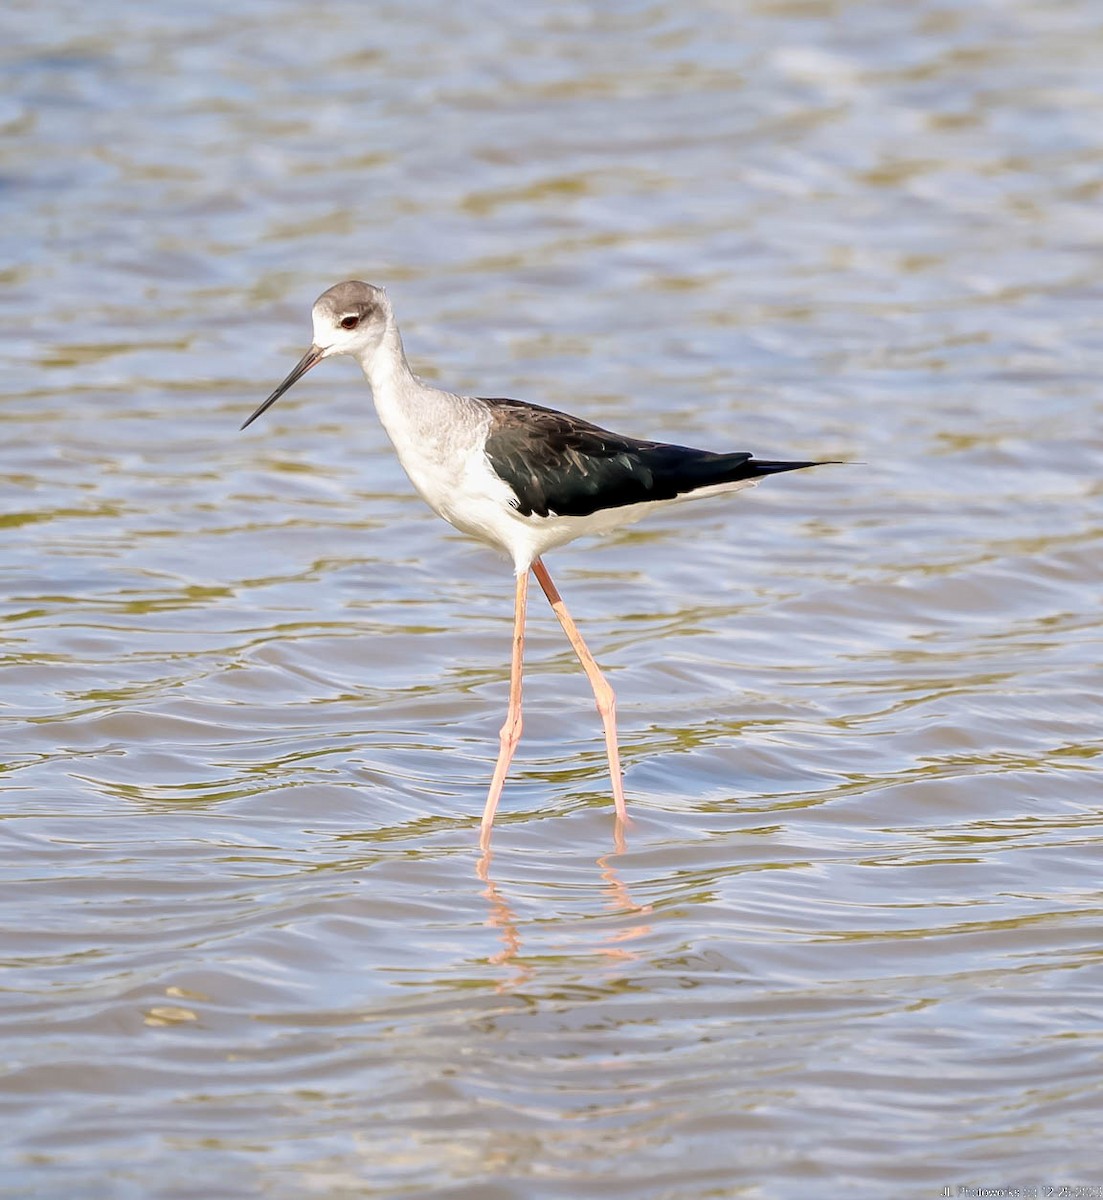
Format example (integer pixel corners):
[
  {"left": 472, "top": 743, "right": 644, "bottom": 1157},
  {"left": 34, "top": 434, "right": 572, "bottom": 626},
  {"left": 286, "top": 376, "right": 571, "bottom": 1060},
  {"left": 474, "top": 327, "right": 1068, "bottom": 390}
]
[{"left": 480, "top": 397, "right": 817, "bottom": 517}]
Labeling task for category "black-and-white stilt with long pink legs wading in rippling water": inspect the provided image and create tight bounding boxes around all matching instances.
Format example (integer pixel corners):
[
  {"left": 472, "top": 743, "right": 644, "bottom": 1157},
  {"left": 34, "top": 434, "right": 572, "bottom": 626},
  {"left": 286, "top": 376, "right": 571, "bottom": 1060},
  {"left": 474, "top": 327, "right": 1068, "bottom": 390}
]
[{"left": 241, "top": 280, "right": 825, "bottom": 850}]
